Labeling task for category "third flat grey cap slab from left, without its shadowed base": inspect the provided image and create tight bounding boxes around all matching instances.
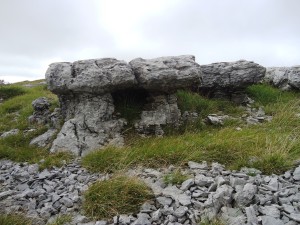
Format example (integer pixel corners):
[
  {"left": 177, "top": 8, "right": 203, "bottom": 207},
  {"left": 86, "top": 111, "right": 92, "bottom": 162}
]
[{"left": 201, "top": 60, "right": 266, "bottom": 89}]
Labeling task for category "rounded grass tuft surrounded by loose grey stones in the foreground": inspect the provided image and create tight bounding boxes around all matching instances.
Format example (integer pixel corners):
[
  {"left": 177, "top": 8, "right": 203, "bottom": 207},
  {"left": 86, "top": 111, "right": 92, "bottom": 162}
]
[{"left": 83, "top": 176, "right": 153, "bottom": 219}]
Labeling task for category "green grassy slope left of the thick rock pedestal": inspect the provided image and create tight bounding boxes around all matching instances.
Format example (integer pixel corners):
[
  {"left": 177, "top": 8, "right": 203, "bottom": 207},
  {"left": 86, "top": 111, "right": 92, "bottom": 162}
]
[{"left": 0, "top": 82, "right": 71, "bottom": 169}]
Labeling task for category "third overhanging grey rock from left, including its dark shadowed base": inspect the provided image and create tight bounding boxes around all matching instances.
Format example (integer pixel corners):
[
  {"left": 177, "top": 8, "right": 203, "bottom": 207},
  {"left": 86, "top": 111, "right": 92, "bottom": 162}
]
[{"left": 200, "top": 60, "right": 266, "bottom": 103}]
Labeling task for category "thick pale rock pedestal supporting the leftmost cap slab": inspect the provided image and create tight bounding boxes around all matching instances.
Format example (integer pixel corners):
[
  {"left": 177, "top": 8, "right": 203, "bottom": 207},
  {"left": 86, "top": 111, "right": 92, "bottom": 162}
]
[{"left": 50, "top": 94, "right": 125, "bottom": 156}]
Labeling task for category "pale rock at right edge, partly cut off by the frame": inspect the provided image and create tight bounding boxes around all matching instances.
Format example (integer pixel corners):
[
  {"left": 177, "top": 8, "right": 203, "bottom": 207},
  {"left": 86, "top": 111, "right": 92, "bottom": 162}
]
[{"left": 265, "top": 66, "right": 300, "bottom": 90}]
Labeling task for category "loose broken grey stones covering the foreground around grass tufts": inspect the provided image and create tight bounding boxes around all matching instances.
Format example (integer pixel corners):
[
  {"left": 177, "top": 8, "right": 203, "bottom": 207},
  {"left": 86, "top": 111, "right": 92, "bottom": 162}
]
[{"left": 0, "top": 160, "right": 300, "bottom": 225}]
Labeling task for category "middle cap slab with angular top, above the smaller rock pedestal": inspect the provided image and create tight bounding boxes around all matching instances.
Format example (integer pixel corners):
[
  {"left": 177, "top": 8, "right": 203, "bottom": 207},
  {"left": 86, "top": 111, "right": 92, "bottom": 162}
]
[{"left": 129, "top": 55, "right": 202, "bottom": 92}]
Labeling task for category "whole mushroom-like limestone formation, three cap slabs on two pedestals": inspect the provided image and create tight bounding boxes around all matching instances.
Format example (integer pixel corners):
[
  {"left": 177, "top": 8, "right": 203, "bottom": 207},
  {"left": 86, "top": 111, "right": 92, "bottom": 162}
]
[{"left": 46, "top": 55, "right": 265, "bottom": 156}]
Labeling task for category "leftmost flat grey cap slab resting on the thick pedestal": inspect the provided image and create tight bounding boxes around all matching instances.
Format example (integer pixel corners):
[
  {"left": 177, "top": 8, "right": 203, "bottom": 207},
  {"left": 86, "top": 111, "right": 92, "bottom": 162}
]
[{"left": 46, "top": 58, "right": 136, "bottom": 94}]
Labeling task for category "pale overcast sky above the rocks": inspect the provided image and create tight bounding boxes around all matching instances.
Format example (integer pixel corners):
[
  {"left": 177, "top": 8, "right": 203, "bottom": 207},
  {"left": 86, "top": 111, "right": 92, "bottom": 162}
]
[{"left": 0, "top": 0, "right": 300, "bottom": 82}]
